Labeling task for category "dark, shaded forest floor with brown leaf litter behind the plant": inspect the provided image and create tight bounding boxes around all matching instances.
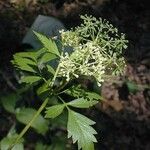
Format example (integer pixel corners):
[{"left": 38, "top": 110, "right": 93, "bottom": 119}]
[{"left": 0, "top": 0, "right": 150, "bottom": 150}]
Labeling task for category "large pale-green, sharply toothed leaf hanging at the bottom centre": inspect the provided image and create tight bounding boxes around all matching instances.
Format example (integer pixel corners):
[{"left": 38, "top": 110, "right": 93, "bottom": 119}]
[{"left": 67, "top": 110, "right": 97, "bottom": 150}]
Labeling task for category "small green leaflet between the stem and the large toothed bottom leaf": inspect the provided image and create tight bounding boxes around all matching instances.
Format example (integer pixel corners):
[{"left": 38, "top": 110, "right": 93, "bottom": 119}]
[{"left": 45, "top": 104, "right": 65, "bottom": 118}]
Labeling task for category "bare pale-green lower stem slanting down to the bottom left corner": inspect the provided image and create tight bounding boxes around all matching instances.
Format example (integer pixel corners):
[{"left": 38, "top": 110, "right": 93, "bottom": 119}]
[{"left": 8, "top": 98, "right": 48, "bottom": 150}]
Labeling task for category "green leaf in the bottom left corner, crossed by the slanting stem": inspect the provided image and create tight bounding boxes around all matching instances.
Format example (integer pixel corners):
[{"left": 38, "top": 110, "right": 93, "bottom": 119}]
[{"left": 0, "top": 134, "right": 24, "bottom": 150}]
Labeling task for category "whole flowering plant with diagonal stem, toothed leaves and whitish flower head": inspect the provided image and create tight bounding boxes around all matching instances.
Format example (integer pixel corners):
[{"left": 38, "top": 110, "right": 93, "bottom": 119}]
[{"left": 10, "top": 15, "right": 128, "bottom": 150}]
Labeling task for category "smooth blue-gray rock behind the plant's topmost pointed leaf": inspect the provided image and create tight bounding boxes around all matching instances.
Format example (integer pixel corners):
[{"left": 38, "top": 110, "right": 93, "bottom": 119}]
[{"left": 22, "top": 15, "right": 65, "bottom": 49}]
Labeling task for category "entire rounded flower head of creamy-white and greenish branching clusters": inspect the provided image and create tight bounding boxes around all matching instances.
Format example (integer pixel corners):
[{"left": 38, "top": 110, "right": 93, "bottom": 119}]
[{"left": 59, "top": 15, "right": 128, "bottom": 86}]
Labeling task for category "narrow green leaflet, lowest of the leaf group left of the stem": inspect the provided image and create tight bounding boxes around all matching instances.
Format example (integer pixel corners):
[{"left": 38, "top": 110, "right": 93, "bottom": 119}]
[{"left": 20, "top": 76, "right": 42, "bottom": 84}]
